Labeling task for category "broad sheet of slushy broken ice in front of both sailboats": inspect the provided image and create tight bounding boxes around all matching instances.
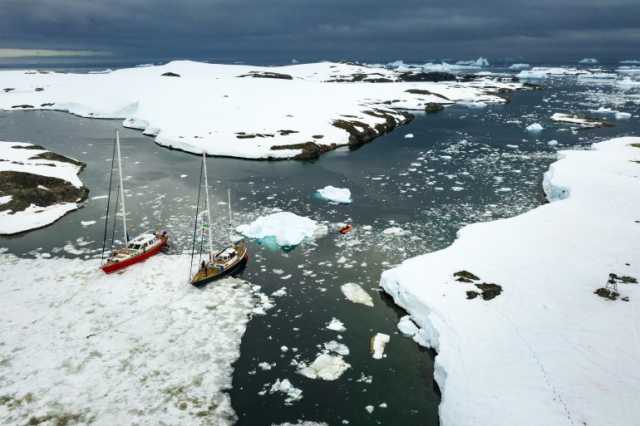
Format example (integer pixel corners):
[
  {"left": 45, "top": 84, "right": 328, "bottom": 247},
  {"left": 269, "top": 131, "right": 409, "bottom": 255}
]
[{"left": 0, "top": 255, "right": 256, "bottom": 425}]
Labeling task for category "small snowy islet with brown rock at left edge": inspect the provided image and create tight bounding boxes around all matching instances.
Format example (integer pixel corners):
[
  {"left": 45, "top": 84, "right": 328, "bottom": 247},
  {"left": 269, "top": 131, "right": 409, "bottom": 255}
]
[{"left": 0, "top": 141, "right": 89, "bottom": 235}]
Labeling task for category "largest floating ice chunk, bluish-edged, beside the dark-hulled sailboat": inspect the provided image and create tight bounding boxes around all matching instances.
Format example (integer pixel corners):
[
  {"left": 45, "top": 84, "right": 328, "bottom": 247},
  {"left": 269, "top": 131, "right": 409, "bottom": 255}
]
[{"left": 236, "top": 212, "right": 326, "bottom": 247}]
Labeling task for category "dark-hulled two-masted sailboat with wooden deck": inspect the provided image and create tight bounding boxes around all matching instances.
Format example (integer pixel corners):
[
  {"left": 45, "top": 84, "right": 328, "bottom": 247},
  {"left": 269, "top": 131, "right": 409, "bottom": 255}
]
[{"left": 189, "top": 152, "right": 249, "bottom": 287}]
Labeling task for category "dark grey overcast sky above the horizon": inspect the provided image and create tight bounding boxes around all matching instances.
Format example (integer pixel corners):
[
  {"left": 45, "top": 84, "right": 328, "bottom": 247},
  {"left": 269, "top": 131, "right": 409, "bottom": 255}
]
[{"left": 0, "top": 0, "right": 640, "bottom": 62}]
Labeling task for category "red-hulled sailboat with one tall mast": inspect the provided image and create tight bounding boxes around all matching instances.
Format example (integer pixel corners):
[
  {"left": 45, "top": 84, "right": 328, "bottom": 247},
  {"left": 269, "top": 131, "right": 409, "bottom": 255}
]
[{"left": 100, "top": 130, "right": 169, "bottom": 274}]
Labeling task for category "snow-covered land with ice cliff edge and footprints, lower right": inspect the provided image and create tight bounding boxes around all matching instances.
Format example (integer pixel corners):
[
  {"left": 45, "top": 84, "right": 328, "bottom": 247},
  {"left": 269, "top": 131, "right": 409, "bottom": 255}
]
[{"left": 380, "top": 137, "right": 640, "bottom": 426}]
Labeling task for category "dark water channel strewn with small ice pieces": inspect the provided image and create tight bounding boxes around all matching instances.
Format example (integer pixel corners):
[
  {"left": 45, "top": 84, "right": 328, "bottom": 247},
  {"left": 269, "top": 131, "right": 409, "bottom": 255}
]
[{"left": 0, "top": 75, "right": 640, "bottom": 425}]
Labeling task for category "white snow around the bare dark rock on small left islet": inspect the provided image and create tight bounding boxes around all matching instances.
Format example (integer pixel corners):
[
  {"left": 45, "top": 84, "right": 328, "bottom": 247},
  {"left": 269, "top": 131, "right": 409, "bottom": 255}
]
[{"left": 0, "top": 141, "right": 82, "bottom": 235}]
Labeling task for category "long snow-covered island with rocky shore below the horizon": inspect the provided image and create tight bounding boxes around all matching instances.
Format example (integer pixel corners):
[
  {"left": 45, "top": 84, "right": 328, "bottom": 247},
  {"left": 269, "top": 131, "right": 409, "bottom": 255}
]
[{"left": 0, "top": 61, "right": 525, "bottom": 159}]
